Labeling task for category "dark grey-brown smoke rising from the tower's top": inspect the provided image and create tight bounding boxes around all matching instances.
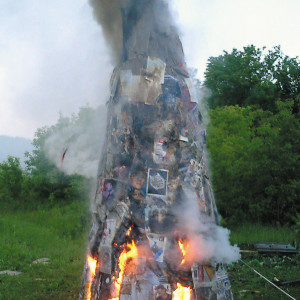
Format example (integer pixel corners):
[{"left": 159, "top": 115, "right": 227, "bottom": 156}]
[{"left": 90, "top": 0, "right": 178, "bottom": 63}]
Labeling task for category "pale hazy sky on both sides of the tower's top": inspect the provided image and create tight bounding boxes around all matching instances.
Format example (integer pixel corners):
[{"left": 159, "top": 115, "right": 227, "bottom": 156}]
[{"left": 0, "top": 0, "right": 300, "bottom": 139}]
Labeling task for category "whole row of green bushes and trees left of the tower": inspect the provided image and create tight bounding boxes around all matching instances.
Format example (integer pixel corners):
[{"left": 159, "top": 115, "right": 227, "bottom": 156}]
[{"left": 0, "top": 107, "right": 96, "bottom": 209}]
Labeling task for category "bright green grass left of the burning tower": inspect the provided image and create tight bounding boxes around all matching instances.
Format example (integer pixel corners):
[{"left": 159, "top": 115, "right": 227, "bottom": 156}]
[{"left": 0, "top": 204, "right": 87, "bottom": 299}]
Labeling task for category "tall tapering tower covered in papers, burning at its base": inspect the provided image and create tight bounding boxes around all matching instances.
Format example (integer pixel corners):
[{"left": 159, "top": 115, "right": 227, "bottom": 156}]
[{"left": 80, "top": 0, "right": 237, "bottom": 300}]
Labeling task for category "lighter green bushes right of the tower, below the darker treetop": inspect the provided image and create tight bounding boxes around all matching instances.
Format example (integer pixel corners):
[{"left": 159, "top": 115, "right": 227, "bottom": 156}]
[{"left": 208, "top": 100, "right": 300, "bottom": 223}]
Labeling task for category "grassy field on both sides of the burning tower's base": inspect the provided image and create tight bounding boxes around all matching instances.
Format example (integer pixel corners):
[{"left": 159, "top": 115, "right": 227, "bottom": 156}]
[{"left": 0, "top": 203, "right": 300, "bottom": 299}]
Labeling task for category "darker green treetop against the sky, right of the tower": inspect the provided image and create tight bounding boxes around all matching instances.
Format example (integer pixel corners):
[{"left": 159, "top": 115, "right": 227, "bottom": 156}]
[{"left": 205, "top": 45, "right": 300, "bottom": 111}]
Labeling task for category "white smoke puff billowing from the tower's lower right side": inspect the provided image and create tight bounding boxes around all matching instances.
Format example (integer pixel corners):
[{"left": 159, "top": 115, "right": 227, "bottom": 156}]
[{"left": 176, "top": 189, "right": 240, "bottom": 264}]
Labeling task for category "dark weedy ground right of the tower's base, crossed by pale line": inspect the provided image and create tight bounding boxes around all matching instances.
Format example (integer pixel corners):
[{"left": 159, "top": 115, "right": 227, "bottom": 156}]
[{"left": 227, "top": 224, "right": 300, "bottom": 299}]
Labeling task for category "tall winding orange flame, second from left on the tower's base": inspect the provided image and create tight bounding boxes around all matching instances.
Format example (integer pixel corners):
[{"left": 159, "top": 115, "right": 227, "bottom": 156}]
[{"left": 110, "top": 241, "right": 138, "bottom": 300}]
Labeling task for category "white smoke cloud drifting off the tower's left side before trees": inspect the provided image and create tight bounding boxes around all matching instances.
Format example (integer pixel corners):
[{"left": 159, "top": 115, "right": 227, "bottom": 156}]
[{"left": 44, "top": 106, "right": 106, "bottom": 178}]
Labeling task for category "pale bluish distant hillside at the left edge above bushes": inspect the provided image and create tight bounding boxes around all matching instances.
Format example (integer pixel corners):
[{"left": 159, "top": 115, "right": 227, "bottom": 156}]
[{"left": 0, "top": 135, "right": 33, "bottom": 162}]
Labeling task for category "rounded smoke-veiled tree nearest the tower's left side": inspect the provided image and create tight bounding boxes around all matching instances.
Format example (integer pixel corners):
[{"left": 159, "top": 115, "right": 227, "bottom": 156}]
[{"left": 25, "top": 107, "right": 95, "bottom": 209}]
